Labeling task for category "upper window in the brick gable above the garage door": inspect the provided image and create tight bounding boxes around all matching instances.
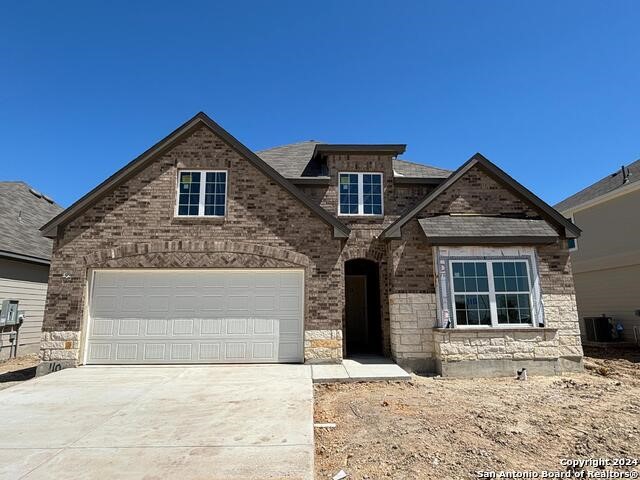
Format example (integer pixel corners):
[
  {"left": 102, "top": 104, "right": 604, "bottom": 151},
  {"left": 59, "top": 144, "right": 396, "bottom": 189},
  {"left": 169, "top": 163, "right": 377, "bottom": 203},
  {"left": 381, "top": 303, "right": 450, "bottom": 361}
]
[{"left": 176, "top": 170, "right": 227, "bottom": 217}]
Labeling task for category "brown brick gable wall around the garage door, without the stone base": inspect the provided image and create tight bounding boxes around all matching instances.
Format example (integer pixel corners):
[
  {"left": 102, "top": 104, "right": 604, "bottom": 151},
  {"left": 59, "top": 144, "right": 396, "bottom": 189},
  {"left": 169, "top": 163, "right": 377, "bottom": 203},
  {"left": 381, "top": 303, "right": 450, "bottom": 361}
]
[{"left": 43, "top": 127, "right": 344, "bottom": 362}]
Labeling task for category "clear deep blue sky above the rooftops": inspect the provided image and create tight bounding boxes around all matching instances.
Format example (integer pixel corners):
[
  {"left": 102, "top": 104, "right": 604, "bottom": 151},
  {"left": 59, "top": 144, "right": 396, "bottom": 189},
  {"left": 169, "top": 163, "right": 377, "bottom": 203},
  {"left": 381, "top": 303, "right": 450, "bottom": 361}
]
[{"left": 0, "top": 0, "right": 640, "bottom": 206}]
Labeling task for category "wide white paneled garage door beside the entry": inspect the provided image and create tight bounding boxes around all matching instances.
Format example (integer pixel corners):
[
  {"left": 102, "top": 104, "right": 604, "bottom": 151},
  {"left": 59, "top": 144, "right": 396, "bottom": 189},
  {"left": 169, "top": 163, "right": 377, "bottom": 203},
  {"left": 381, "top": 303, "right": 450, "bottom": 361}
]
[{"left": 84, "top": 269, "right": 304, "bottom": 364}]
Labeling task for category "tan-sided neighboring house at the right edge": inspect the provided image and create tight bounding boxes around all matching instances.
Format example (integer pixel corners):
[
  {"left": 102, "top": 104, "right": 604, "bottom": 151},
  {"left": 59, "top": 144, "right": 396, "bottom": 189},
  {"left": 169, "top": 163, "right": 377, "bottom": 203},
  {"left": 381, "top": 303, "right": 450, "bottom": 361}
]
[{"left": 556, "top": 160, "right": 640, "bottom": 341}]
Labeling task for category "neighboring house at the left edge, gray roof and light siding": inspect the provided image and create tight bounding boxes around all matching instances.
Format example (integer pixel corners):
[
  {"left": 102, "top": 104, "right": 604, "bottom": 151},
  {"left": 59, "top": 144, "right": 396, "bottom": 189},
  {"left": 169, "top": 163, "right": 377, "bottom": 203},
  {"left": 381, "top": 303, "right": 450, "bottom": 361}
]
[{"left": 0, "top": 182, "right": 62, "bottom": 361}]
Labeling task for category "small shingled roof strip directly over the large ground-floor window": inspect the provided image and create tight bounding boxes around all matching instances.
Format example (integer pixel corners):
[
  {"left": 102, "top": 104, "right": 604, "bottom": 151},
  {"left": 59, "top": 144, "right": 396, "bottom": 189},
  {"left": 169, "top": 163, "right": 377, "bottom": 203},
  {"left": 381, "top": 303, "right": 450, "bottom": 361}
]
[{"left": 418, "top": 215, "right": 558, "bottom": 239}]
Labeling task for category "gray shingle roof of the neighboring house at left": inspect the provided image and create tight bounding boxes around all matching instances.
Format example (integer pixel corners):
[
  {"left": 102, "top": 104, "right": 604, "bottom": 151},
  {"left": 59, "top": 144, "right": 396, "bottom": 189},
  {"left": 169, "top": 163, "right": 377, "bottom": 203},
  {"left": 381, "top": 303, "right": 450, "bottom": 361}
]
[{"left": 0, "top": 182, "right": 62, "bottom": 264}]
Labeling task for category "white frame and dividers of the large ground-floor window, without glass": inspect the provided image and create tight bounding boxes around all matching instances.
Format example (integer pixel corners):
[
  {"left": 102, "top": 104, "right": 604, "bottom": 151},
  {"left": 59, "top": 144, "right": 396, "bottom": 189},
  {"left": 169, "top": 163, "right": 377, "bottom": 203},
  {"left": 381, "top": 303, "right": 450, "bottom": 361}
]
[{"left": 449, "top": 257, "right": 537, "bottom": 328}]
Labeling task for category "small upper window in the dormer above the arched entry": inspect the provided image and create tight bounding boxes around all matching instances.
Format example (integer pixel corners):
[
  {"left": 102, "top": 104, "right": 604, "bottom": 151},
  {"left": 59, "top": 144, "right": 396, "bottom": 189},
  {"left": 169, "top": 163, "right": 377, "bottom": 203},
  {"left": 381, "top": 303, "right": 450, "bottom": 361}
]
[{"left": 338, "top": 172, "right": 383, "bottom": 215}]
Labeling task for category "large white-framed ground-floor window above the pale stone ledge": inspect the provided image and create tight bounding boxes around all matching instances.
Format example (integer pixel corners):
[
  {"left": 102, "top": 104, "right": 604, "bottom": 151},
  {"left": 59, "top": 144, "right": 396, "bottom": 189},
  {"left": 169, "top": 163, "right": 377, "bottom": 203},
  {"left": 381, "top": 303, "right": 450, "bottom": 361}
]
[{"left": 451, "top": 260, "right": 533, "bottom": 327}]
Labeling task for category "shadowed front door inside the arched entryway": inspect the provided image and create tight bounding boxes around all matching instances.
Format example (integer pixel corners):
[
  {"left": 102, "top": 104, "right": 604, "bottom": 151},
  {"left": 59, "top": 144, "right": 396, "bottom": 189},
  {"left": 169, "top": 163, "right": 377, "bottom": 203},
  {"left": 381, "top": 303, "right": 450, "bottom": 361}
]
[{"left": 345, "top": 275, "right": 369, "bottom": 353}]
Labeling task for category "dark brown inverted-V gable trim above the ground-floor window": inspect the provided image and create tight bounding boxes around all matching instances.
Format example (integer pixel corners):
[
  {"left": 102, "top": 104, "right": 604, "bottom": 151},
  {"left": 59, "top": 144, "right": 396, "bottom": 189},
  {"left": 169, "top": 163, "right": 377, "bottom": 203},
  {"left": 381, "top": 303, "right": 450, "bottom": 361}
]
[{"left": 379, "top": 153, "right": 581, "bottom": 239}]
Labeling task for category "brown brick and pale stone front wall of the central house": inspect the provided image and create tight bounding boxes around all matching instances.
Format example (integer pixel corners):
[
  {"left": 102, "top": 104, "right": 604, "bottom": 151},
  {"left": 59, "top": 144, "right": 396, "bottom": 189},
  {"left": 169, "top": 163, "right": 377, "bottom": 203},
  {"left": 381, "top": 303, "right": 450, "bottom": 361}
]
[{"left": 41, "top": 119, "right": 582, "bottom": 376}]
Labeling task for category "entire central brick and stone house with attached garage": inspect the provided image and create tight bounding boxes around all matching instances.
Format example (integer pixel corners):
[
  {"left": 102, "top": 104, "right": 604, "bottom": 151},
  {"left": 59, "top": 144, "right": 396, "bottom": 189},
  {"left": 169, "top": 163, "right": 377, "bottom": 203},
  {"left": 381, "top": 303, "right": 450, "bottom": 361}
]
[{"left": 37, "top": 113, "right": 582, "bottom": 375}]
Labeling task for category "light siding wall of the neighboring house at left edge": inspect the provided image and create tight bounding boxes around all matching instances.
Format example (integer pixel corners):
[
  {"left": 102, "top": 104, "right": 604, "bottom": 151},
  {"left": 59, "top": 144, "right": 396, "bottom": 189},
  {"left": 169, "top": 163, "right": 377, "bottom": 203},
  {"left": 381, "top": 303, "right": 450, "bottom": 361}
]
[{"left": 0, "top": 259, "right": 49, "bottom": 360}]
